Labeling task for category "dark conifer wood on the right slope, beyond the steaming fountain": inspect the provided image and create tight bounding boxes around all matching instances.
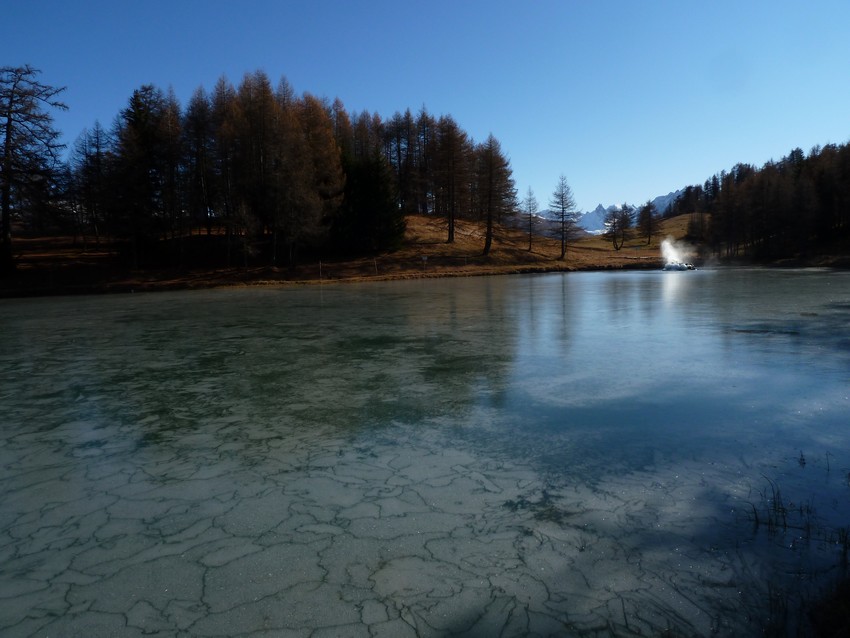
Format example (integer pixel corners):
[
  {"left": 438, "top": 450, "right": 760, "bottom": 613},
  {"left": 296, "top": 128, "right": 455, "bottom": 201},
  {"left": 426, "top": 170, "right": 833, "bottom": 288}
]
[{"left": 665, "top": 144, "right": 850, "bottom": 259}]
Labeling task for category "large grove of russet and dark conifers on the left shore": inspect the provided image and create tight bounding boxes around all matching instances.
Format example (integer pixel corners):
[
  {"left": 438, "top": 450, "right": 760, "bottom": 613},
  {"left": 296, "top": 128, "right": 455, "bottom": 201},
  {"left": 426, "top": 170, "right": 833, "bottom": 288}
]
[{"left": 0, "top": 66, "right": 517, "bottom": 267}]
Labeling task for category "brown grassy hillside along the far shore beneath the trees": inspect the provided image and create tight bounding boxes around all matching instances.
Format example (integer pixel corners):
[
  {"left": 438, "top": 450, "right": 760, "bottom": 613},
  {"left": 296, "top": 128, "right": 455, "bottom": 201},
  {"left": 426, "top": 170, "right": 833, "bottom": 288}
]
[{"left": 0, "top": 216, "right": 687, "bottom": 297}]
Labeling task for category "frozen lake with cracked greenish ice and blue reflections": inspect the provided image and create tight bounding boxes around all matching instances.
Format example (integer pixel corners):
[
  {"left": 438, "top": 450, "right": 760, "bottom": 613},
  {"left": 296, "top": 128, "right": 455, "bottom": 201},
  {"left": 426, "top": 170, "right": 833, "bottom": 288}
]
[{"left": 0, "top": 270, "right": 850, "bottom": 637}]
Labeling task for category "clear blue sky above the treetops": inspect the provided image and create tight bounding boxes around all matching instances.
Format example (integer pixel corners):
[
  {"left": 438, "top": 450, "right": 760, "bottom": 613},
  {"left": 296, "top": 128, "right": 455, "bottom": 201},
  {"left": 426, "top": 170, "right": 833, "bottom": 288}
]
[{"left": 0, "top": 0, "right": 850, "bottom": 210}]
